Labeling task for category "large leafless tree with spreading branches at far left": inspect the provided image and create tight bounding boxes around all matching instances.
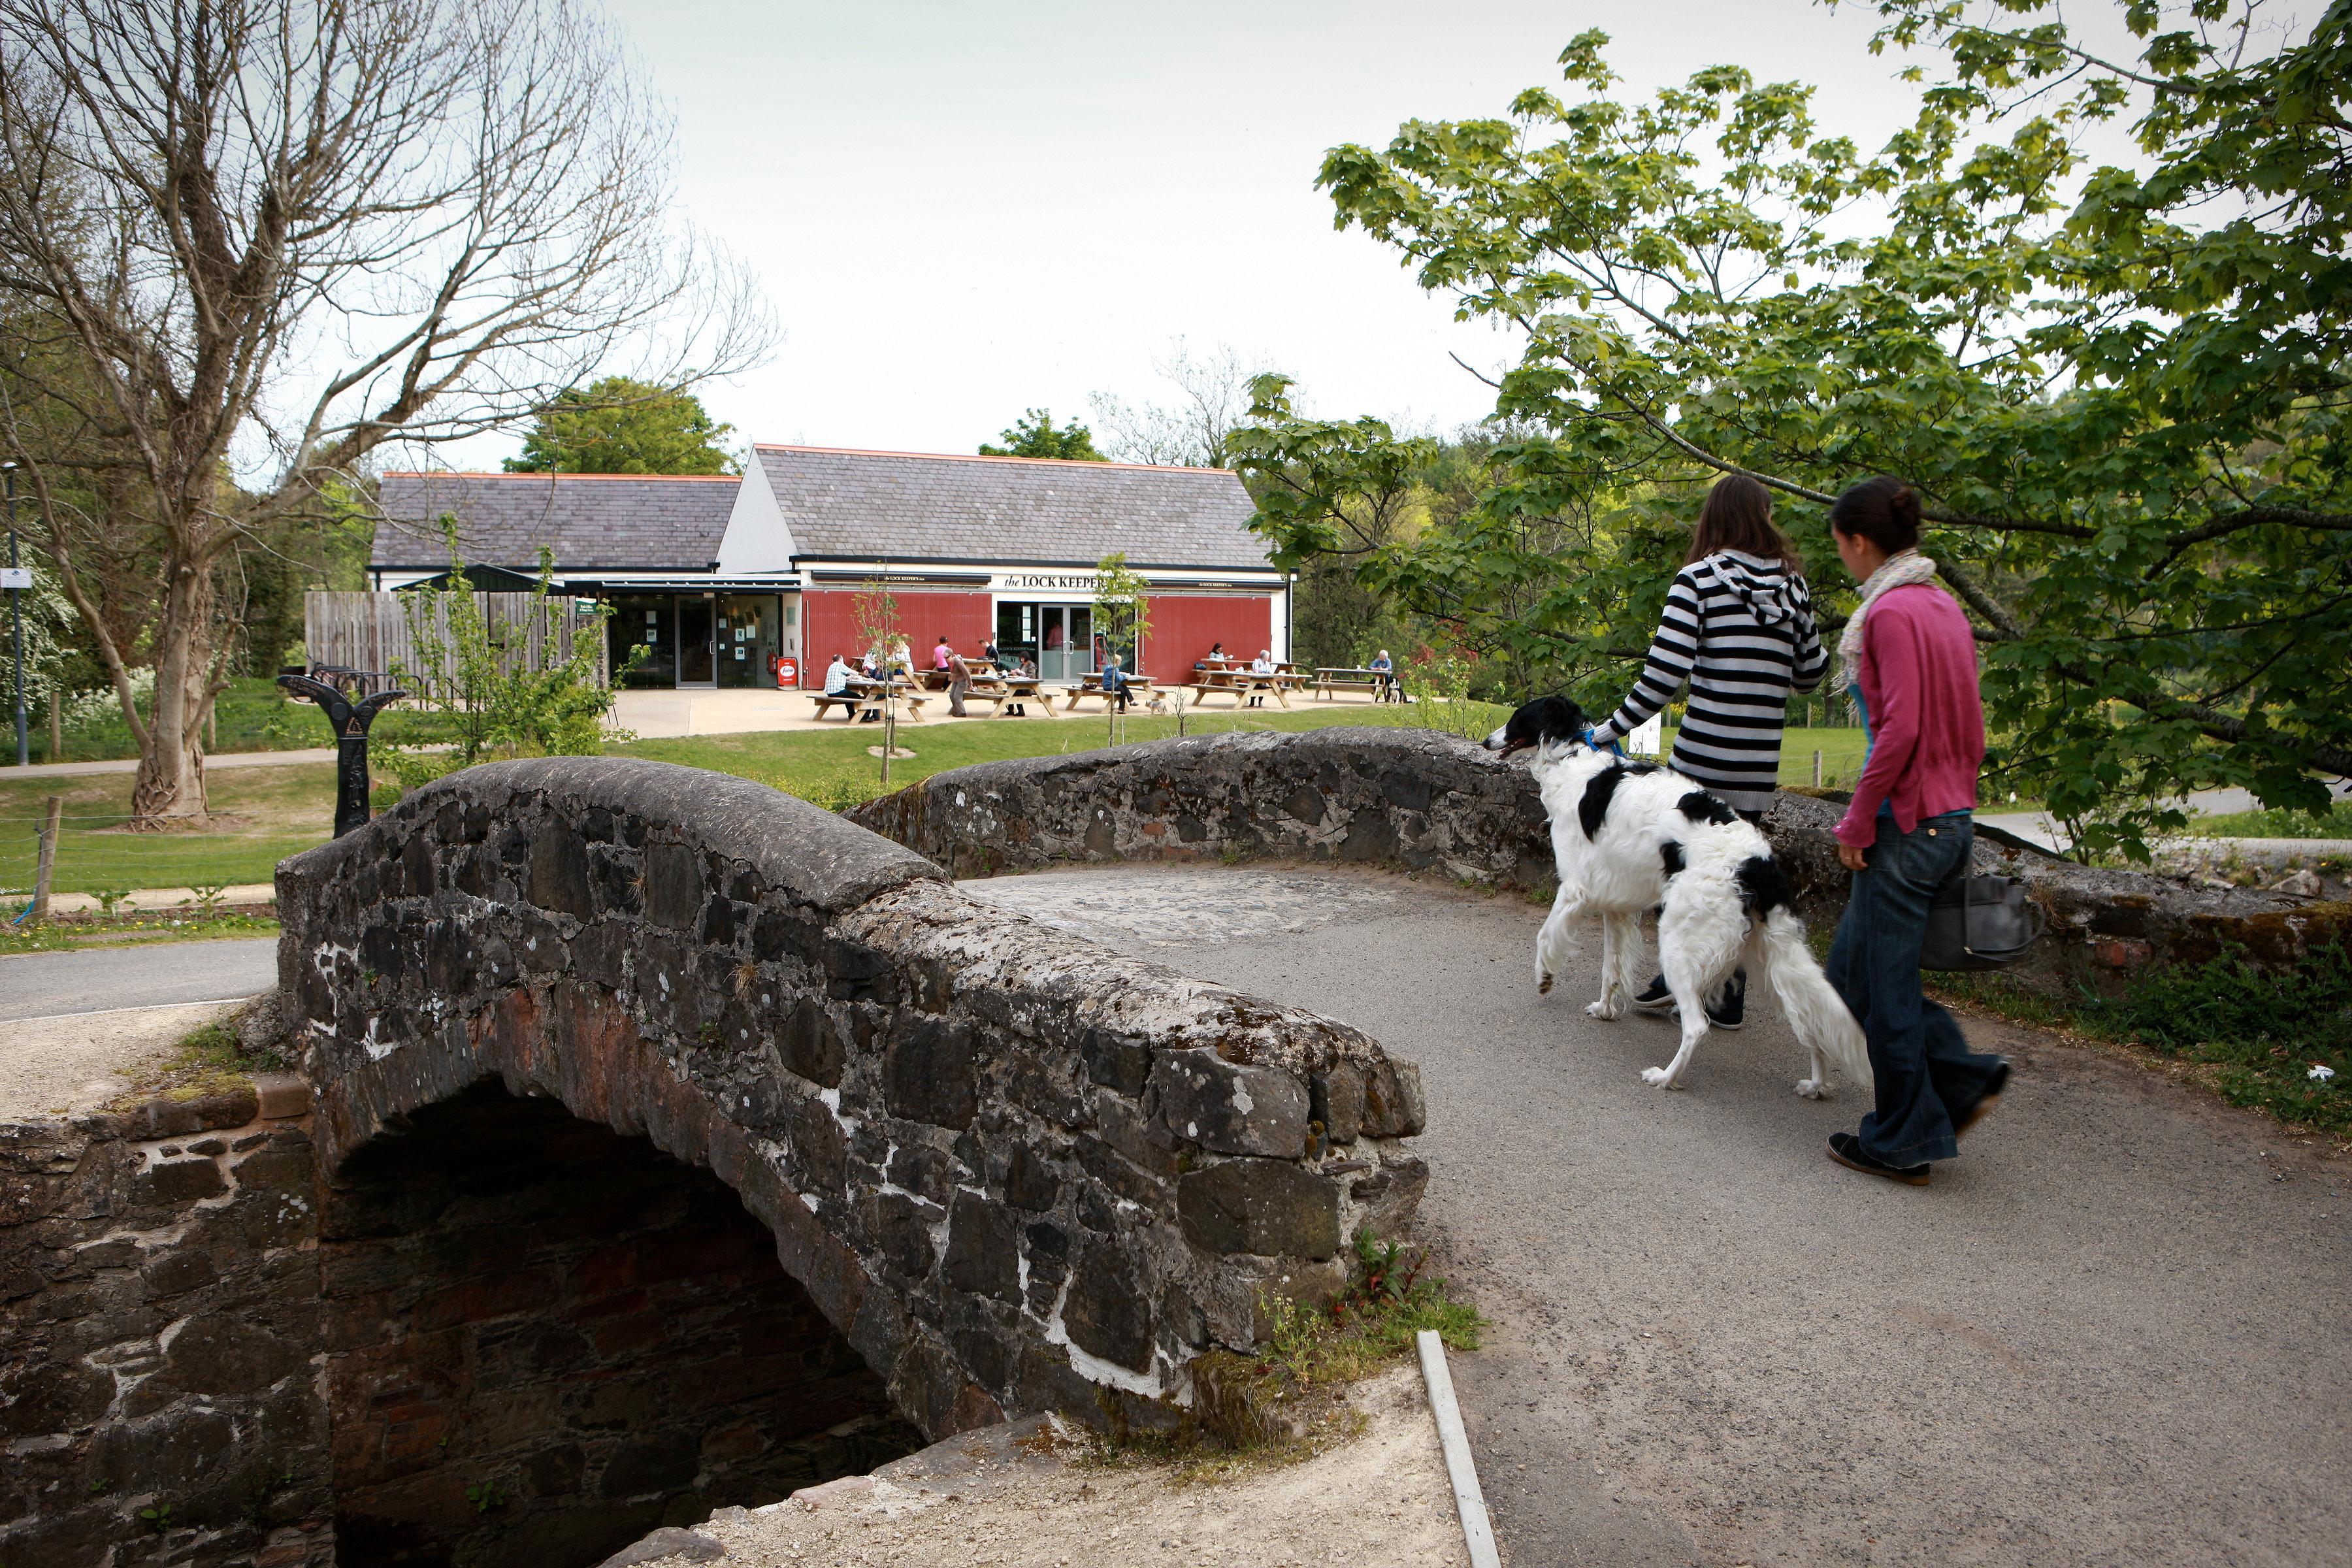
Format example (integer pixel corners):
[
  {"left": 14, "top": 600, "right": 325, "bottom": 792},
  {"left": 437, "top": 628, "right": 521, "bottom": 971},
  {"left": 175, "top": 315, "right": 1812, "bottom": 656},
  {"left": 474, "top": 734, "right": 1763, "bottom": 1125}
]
[{"left": 0, "top": 0, "right": 774, "bottom": 825}]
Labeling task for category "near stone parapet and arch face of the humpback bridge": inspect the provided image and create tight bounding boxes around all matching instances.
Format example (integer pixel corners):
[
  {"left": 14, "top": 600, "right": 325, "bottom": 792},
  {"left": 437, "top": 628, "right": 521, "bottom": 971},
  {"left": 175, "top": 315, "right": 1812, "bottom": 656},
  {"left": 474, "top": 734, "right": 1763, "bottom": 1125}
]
[{"left": 278, "top": 759, "right": 1426, "bottom": 1439}]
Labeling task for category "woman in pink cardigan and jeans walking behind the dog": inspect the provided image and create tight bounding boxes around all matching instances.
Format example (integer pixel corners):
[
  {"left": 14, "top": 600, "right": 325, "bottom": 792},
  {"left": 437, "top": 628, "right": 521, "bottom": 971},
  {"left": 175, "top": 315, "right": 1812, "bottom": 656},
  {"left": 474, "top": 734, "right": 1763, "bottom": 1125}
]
[{"left": 1827, "top": 477, "right": 2008, "bottom": 1187}]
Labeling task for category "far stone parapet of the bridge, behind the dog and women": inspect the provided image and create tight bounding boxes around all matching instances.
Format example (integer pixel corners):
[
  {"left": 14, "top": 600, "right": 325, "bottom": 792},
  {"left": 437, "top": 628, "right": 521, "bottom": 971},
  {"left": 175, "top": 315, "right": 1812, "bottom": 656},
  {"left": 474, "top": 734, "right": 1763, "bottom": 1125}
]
[{"left": 851, "top": 727, "right": 2352, "bottom": 994}]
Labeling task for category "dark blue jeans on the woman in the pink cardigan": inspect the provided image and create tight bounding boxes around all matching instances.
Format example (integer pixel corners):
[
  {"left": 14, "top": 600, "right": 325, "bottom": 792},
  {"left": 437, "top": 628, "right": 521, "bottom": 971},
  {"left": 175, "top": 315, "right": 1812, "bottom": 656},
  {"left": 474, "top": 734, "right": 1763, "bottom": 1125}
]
[{"left": 1830, "top": 811, "right": 2002, "bottom": 1166}]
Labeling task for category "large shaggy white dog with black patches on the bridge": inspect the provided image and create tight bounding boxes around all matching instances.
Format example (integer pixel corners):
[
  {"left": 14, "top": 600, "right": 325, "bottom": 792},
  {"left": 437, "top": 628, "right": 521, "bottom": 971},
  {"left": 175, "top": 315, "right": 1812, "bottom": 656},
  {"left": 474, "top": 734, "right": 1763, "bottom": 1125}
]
[{"left": 1486, "top": 696, "right": 1870, "bottom": 1100}]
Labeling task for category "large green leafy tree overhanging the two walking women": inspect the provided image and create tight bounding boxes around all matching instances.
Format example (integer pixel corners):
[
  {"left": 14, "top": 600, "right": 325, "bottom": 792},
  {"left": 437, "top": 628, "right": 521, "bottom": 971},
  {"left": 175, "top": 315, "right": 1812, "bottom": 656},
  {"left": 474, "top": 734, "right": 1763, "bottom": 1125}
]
[{"left": 1256, "top": 0, "right": 2352, "bottom": 853}]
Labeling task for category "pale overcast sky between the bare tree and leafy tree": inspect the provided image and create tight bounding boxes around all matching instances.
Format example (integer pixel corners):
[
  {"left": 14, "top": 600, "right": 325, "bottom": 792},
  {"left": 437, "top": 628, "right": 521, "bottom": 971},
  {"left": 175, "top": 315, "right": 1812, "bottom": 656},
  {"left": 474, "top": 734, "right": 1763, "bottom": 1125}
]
[{"left": 529, "top": 0, "right": 1985, "bottom": 461}]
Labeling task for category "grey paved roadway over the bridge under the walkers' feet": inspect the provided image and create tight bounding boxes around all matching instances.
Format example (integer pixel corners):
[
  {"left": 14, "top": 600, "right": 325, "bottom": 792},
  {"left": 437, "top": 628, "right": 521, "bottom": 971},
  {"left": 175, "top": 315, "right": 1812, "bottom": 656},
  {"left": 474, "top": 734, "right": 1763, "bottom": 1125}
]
[{"left": 964, "top": 868, "right": 2352, "bottom": 1568}]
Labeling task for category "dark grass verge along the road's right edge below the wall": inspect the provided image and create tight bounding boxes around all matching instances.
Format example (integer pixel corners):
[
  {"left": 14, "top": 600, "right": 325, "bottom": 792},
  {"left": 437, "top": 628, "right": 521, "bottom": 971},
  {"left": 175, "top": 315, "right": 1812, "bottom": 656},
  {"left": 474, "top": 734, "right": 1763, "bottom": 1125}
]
[{"left": 1933, "top": 945, "right": 2352, "bottom": 1140}]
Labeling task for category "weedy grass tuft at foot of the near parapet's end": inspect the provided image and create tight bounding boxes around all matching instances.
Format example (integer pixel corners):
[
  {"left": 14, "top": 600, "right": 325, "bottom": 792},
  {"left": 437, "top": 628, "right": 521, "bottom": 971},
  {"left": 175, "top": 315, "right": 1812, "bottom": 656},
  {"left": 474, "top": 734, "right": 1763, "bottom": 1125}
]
[{"left": 1085, "top": 1230, "right": 1486, "bottom": 1481}]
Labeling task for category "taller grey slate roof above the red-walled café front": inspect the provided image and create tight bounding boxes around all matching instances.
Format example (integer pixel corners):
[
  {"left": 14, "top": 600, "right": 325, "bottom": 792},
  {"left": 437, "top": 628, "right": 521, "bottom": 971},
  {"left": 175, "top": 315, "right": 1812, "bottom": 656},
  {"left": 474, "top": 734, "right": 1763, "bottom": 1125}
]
[{"left": 757, "top": 447, "right": 1266, "bottom": 569}]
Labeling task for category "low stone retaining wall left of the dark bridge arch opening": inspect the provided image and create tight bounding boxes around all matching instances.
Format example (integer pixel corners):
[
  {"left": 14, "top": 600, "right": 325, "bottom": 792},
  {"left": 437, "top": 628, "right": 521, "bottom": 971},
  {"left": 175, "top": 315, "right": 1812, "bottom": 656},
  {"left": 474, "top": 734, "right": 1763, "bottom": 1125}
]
[{"left": 0, "top": 1081, "right": 334, "bottom": 1568}]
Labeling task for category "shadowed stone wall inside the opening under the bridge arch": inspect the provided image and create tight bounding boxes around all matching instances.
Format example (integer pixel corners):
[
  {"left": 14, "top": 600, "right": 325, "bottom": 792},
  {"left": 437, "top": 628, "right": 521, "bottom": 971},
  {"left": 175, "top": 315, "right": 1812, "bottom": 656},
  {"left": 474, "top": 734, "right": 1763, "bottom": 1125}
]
[{"left": 320, "top": 1084, "right": 922, "bottom": 1568}]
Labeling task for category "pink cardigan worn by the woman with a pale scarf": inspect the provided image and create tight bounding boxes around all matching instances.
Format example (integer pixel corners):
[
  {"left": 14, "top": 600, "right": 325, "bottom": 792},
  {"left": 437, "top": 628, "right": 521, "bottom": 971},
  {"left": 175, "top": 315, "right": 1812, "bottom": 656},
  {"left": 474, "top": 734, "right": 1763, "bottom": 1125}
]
[{"left": 1837, "top": 583, "right": 1985, "bottom": 849}]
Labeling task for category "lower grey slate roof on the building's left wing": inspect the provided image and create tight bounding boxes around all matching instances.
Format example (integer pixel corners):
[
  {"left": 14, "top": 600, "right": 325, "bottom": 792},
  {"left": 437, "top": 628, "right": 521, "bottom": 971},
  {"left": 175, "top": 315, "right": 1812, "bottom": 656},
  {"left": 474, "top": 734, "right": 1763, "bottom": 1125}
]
[{"left": 369, "top": 472, "right": 743, "bottom": 571}]
